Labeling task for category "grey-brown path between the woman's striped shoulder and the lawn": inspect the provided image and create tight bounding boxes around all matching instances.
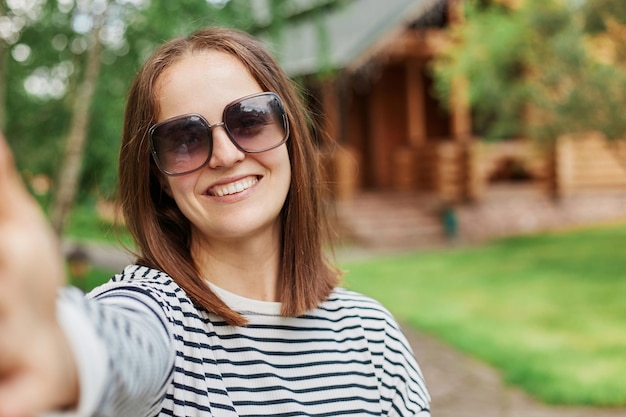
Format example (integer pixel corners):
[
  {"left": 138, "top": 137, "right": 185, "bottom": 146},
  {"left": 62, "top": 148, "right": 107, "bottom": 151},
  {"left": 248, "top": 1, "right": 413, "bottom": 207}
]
[{"left": 403, "top": 326, "right": 626, "bottom": 417}]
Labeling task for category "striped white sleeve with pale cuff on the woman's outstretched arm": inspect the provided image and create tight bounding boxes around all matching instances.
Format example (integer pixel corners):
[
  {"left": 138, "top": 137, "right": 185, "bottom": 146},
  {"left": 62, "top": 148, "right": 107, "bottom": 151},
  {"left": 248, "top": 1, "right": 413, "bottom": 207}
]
[{"left": 45, "top": 284, "right": 174, "bottom": 417}]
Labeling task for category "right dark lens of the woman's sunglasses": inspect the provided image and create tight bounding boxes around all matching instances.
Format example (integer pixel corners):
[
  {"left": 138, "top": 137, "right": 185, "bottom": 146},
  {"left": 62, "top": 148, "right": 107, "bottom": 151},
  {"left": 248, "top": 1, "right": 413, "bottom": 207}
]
[{"left": 224, "top": 94, "right": 286, "bottom": 152}]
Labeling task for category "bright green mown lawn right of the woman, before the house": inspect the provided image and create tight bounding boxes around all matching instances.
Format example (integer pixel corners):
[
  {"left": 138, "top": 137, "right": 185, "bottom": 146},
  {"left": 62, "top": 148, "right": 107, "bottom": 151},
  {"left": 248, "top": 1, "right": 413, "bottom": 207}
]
[{"left": 342, "top": 224, "right": 626, "bottom": 406}]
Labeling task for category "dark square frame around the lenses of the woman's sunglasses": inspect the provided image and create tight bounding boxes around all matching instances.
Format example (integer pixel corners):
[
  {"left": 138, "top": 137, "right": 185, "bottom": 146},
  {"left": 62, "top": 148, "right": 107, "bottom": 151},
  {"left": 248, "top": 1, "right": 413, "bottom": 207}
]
[{"left": 148, "top": 91, "right": 289, "bottom": 177}]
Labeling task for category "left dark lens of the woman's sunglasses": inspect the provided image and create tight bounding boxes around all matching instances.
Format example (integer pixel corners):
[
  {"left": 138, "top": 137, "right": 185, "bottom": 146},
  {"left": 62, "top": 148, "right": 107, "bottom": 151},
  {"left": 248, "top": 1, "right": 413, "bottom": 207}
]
[{"left": 152, "top": 116, "right": 211, "bottom": 174}]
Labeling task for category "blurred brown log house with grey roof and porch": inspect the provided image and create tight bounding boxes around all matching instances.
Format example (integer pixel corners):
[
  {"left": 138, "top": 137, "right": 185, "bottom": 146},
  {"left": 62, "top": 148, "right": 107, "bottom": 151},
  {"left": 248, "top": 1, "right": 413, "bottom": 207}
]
[{"left": 256, "top": 0, "right": 626, "bottom": 247}]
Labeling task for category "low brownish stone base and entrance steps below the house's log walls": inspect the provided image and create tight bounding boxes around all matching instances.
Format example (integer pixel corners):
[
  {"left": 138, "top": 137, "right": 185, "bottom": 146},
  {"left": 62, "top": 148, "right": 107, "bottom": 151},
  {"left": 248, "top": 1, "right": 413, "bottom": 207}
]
[{"left": 336, "top": 184, "right": 626, "bottom": 252}]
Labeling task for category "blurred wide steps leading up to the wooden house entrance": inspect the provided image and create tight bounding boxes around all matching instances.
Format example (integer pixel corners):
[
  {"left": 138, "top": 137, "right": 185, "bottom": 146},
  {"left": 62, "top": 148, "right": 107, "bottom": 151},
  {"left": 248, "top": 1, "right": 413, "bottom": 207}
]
[{"left": 337, "top": 192, "right": 446, "bottom": 250}]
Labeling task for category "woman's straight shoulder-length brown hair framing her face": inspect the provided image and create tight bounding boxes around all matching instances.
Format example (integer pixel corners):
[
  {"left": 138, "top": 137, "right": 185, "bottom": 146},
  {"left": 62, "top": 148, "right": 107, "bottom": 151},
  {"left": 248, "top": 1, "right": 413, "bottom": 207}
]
[{"left": 119, "top": 28, "right": 340, "bottom": 325}]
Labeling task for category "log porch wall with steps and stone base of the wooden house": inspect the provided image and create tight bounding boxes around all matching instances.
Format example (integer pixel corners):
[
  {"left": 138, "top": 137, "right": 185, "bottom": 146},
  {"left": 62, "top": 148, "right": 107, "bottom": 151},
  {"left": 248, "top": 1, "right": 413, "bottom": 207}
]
[{"left": 333, "top": 134, "right": 626, "bottom": 250}]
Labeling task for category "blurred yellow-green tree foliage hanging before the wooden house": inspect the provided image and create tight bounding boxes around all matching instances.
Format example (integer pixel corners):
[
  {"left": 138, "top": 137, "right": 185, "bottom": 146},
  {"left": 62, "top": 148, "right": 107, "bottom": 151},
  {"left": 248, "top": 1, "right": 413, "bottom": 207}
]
[{"left": 433, "top": 0, "right": 626, "bottom": 140}]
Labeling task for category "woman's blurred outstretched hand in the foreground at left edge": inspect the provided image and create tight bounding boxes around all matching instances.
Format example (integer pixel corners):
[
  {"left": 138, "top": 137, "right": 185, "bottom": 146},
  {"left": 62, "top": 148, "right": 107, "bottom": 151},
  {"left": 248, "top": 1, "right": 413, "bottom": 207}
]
[{"left": 0, "top": 133, "right": 78, "bottom": 417}]
